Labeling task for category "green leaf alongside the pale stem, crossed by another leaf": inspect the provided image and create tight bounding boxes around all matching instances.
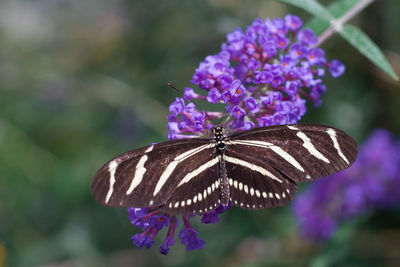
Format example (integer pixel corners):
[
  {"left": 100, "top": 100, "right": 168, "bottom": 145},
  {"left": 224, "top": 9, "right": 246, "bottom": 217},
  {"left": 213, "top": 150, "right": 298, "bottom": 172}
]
[{"left": 306, "top": 0, "right": 362, "bottom": 35}]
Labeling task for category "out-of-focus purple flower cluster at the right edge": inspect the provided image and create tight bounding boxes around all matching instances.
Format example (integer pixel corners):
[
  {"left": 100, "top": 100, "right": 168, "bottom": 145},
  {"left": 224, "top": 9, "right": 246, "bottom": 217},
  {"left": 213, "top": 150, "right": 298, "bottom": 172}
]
[{"left": 293, "top": 130, "right": 400, "bottom": 241}]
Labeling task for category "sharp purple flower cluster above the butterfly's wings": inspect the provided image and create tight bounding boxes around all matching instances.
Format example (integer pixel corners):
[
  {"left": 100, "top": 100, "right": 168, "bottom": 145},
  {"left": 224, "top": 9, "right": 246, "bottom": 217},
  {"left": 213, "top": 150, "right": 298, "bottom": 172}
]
[{"left": 168, "top": 15, "right": 345, "bottom": 139}]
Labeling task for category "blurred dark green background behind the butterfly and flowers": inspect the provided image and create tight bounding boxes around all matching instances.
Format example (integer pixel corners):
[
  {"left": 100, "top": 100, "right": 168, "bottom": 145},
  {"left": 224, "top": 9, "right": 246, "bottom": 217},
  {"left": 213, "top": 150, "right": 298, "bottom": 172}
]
[{"left": 0, "top": 0, "right": 400, "bottom": 267}]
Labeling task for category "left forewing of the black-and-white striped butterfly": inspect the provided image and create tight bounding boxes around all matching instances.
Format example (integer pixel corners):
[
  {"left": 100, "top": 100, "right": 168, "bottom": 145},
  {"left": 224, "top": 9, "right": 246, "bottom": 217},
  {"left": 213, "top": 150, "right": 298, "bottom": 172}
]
[{"left": 92, "top": 139, "right": 218, "bottom": 211}]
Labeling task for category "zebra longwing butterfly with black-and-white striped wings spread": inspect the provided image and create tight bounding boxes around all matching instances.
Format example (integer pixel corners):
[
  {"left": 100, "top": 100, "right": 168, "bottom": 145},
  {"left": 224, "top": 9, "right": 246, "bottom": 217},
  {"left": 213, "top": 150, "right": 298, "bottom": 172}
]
[{"left": 92, "top": 124, "right": 357, "bottom": 215}]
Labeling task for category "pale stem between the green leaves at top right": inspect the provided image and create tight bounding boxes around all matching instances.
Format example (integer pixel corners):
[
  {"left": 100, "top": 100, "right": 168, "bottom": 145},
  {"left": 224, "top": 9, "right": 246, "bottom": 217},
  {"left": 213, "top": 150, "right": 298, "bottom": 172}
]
[{"left": 315, "top": 0, "right": 374, "bottom": 46}]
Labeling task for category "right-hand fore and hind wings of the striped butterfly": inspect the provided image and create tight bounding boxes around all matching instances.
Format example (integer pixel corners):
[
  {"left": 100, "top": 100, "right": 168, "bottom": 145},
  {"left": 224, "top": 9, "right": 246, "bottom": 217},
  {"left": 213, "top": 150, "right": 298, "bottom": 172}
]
[{"left": 225, "top": 124, "right": 357, "bottom": 208}]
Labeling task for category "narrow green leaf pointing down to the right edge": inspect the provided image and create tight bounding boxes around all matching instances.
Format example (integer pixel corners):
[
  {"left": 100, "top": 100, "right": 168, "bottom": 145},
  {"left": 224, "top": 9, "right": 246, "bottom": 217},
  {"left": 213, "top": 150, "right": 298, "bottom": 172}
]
[{"left": 339, "top": 25, "right": 399, "bottom": 81}]
